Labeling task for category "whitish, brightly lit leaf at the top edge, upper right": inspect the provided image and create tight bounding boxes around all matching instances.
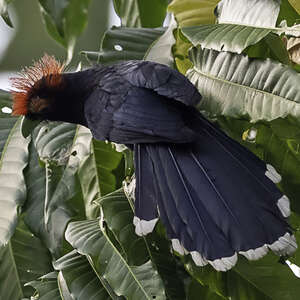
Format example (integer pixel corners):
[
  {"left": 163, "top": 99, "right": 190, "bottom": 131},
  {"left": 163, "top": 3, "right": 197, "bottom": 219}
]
[{"left": 216, "top": 0, "right": 280, "bottom": 27}]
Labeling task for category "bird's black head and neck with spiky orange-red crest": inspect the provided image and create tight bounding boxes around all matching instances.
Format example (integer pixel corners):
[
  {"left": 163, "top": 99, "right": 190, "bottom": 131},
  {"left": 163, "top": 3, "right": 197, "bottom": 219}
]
[{"left": 11, "top": 54, "right": 91, "bottom": 136}]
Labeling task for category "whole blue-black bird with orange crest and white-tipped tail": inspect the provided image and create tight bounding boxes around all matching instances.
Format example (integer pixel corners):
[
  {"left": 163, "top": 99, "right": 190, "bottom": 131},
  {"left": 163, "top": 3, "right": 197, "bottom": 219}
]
[{"left": 12, "top": 55, "right": 297, "bottom": 271}]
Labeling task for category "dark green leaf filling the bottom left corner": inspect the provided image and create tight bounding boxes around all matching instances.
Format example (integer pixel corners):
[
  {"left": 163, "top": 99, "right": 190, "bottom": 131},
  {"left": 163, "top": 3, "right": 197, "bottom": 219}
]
[{"left": 0, "top": 222, "right": 52, "bottom": 300}]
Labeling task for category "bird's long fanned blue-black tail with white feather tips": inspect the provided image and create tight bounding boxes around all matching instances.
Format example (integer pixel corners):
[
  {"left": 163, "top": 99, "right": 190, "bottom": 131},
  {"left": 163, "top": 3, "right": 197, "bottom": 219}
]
[{"left": 134, "top": 116, "right": 297, "bottom": 271}]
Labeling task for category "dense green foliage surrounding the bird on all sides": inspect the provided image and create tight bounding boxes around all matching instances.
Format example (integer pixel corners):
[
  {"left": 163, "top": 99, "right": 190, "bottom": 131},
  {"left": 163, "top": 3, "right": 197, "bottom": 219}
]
[{"left": 0, "top": 0, "right": 300, "bottom": 300}]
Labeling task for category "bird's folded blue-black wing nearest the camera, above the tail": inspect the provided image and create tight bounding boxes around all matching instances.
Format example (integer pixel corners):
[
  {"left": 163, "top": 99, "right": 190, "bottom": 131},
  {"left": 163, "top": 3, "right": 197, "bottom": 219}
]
[{"left": 85, "top": 81, "right": 195, "bottom": 144}]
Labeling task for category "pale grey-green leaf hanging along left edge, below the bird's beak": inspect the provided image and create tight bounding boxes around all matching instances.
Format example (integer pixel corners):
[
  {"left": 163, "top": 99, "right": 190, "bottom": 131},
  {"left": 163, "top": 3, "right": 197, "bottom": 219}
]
[{"left": 0, "top": 116, "right": 28, "bottom": 246}]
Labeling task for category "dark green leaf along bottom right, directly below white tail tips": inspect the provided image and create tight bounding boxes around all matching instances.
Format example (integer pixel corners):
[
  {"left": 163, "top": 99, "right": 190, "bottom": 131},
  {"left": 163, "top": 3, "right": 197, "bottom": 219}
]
[{"left": 186, "top": 253, "right": 300, "bottom": 300}]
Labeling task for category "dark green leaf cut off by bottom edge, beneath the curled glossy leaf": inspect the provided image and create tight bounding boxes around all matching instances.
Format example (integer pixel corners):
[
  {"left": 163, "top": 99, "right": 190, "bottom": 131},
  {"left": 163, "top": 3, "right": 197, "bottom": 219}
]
[{"left": 54, "top": 250, "right": 111, "bottom": 300}]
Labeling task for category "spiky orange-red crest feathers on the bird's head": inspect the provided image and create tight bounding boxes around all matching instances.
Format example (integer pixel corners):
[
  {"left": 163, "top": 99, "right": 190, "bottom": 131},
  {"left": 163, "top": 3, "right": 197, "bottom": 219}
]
[{"left": 11, "top": 54, "right": 64, "bottom": 115}]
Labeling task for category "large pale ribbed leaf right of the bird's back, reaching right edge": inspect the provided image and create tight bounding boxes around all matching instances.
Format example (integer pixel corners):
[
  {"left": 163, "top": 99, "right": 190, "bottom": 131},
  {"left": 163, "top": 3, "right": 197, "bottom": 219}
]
[{"left": 187, "top": 48, "right": 300, "bottom": 123}]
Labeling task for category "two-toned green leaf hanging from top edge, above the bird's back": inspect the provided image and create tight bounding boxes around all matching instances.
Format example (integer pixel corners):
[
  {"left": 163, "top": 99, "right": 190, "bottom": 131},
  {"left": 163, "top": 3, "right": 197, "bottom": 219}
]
[{"left": 114, "top": 0, "right": 168, "bottom": 27}]
